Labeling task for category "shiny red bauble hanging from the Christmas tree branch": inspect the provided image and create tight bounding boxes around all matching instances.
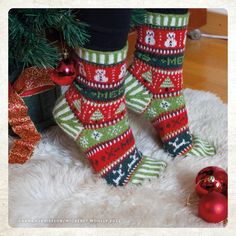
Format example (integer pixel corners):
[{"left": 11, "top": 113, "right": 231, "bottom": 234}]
[{"left": 51, "top": 59, "right": 76, "bottom": 85}]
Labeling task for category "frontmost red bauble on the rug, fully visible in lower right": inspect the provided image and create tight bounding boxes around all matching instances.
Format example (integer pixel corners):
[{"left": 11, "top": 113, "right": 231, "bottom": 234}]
[{"left": 198, "top": 192, "right": 228, "bottom": 223}]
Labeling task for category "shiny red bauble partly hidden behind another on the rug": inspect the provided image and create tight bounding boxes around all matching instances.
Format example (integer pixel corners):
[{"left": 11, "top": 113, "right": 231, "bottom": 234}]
[{"left": 195, "top": 166, "right": 228, "bottom": 197}]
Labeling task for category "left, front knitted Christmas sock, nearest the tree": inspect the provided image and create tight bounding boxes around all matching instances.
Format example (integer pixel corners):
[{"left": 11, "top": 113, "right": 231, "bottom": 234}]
[{"left": 53, "top": 44, "right": 166, "bottom": 186}]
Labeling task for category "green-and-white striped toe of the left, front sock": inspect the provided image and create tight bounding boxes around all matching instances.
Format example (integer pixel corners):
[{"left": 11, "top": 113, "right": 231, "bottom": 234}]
[{"left": 130, "top": 157, "right": 167, "bottom": 184}]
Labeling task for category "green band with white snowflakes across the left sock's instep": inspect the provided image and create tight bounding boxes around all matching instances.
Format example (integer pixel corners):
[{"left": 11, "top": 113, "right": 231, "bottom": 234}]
[{"left": 77, "top": 115, "right": 130, "bottom": 151}]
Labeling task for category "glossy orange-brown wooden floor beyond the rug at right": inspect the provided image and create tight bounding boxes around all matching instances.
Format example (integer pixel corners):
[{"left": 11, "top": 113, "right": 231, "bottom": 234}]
[{"left": 184, "top": 38, "right": 227, "bottom": 103}]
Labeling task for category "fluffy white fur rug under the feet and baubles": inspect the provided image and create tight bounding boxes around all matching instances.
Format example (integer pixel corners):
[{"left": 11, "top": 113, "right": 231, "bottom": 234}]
[{"left": 9, "top": 89, "right": 227, "bottom": 227}]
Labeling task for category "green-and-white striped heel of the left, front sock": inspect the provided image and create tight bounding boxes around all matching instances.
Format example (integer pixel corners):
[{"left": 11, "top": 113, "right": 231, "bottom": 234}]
[{"left": 53, "top": 96, "right": 84, "bottom": 140}]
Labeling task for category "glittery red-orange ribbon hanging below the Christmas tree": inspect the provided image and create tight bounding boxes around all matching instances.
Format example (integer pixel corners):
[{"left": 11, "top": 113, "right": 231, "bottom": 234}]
[{"left": 8, "top": 67, "right": 55, "bottom": 164}]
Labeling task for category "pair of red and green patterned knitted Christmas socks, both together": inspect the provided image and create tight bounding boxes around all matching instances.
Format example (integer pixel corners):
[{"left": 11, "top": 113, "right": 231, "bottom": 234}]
[{"left": 53, "top": 8, "right": 213, "bottom": 186}]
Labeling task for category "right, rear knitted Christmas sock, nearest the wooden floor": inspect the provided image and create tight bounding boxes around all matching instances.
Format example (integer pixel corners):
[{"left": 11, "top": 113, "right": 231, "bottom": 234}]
[{"left": 125, "top": 12, "right": 214, "bottom": 156}]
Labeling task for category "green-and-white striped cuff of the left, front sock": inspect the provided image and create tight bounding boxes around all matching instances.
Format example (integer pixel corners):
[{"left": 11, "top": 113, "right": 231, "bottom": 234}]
[{"left": 76, "top": 43, "right": 128, "bottom": 65}]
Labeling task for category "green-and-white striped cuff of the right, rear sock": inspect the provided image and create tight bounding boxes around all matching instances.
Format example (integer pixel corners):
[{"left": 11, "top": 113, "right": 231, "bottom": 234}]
[{"left": 145, "top": 12, "right": 189, "bottom": 27}]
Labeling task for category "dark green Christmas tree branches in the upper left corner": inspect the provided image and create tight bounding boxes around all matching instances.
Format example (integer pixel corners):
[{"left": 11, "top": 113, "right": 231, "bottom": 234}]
[{"left": 9, "top": 9, "right": 88, "bottom": 71}]
